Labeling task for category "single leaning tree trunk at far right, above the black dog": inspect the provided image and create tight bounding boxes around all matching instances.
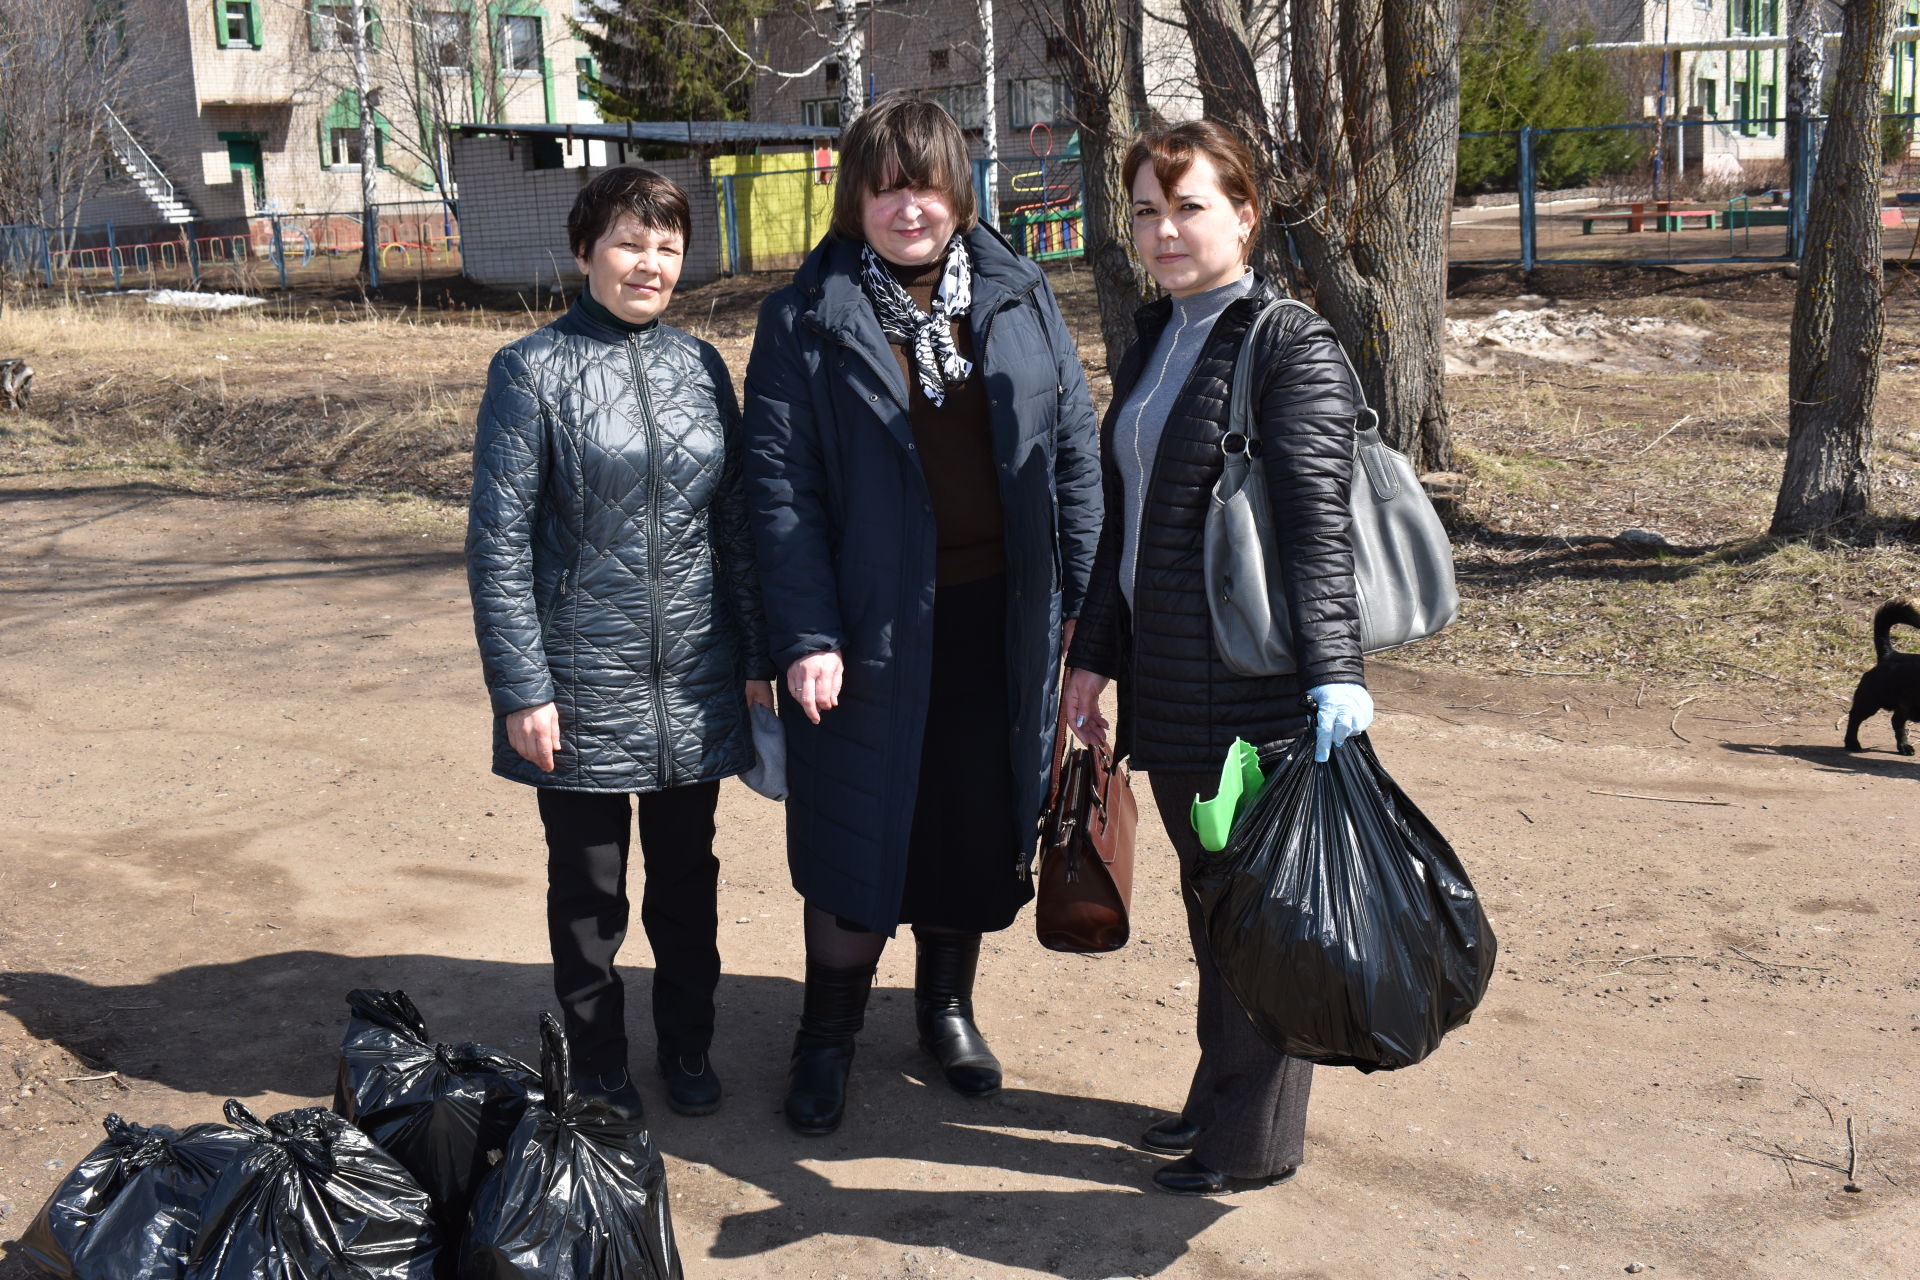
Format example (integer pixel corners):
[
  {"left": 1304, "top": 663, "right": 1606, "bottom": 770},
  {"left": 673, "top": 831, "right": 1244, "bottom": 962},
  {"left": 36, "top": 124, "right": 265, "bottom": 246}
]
[{"left": 1772, "top": 0, "right": 1893, "bottom": 537}]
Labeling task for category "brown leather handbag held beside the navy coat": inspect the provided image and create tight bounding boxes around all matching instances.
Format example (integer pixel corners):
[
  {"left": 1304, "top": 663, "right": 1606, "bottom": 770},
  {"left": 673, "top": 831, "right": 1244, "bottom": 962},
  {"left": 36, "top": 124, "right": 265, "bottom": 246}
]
[{"left": 1033, "top": 706, "right": 1140, "bottom": 952}]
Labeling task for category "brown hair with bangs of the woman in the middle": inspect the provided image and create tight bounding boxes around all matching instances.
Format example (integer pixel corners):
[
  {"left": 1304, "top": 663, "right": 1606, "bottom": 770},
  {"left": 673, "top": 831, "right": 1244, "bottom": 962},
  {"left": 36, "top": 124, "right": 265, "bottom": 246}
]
[{"left": 833, "top": 94, "right": 979, "bottom": 240}]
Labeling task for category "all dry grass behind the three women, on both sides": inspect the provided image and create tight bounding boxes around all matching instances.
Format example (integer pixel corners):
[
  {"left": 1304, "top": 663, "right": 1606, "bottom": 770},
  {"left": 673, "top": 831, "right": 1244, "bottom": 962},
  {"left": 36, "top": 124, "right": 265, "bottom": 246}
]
[{"left": 0, "top": 271, "right": 1920, "bottom": 699}]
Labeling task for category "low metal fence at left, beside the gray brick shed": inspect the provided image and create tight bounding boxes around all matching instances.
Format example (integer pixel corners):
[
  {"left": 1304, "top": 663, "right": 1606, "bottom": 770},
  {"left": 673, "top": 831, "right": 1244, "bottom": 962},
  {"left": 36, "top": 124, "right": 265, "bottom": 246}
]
[{"left": 0, "top": 200, "right": 461, "bottom": 294}]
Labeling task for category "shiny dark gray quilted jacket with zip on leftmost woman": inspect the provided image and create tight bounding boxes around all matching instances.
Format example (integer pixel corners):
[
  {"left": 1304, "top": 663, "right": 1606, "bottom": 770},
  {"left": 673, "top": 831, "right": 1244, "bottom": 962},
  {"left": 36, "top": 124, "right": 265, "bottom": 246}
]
[{"left": 467, "top": 305, "right": 772, "bottom": 791}]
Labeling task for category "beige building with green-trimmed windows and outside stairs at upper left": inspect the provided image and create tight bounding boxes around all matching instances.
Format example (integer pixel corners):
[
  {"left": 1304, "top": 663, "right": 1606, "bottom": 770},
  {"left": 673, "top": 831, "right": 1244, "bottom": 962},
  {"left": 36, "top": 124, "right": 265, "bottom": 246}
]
[{"left": 81, "top": 0, "right": 599, "bottom": 223}]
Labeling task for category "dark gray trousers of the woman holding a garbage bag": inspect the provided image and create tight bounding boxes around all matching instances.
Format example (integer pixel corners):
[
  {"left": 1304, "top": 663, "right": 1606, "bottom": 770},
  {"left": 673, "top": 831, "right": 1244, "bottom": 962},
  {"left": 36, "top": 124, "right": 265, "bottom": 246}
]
[{"left": 1148, "top": 773, "right": 1313, "bottom": 1178}]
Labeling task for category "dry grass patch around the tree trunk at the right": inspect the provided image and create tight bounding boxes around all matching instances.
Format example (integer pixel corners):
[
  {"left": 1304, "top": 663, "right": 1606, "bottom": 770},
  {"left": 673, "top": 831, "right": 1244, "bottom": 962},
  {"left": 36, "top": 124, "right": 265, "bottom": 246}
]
[{"left": 1396, "top": 316, "right": 1920, "bottom": 699}]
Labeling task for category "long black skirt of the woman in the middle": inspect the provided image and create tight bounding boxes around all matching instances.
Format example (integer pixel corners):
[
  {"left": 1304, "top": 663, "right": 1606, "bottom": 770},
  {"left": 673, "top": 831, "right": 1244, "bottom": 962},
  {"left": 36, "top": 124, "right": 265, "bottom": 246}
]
[{"left": 900, "top": 574, "right": 1033, "bottom": 933}]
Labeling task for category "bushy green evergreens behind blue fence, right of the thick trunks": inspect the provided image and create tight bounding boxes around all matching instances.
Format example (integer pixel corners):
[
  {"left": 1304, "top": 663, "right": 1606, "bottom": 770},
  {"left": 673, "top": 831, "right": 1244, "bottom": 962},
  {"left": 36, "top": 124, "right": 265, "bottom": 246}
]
[{"left": 1455, "top": 0, "right": 1642, "bottom": 194}]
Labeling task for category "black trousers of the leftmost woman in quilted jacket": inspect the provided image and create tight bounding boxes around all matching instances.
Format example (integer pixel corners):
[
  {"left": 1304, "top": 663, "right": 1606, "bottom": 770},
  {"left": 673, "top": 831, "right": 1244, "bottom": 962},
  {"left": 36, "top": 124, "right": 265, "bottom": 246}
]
[{"left": 540, "top": 783, "right": 720, "bottom": 1075}]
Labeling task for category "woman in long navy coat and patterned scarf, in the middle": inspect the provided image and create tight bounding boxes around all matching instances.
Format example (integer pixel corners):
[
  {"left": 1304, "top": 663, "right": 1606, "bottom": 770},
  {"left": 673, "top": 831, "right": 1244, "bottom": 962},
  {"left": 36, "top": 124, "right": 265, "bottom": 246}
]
[{"left": 745, "top": 98, "right": 1100, "bottom": 1134}]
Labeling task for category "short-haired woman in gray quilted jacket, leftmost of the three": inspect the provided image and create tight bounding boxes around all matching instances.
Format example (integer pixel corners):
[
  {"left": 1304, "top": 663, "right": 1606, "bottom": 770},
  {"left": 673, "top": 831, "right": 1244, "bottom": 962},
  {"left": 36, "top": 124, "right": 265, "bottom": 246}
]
[{"left": 467, "top": 165, "right": 772, "bottom": 1115}]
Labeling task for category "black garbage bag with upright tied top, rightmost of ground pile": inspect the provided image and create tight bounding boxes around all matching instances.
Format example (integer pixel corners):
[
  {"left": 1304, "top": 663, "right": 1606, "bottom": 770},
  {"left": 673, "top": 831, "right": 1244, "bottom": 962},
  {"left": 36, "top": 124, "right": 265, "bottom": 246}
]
[{"left": 461, "top": 1013, "right": 682, "bottom": 1280}]
